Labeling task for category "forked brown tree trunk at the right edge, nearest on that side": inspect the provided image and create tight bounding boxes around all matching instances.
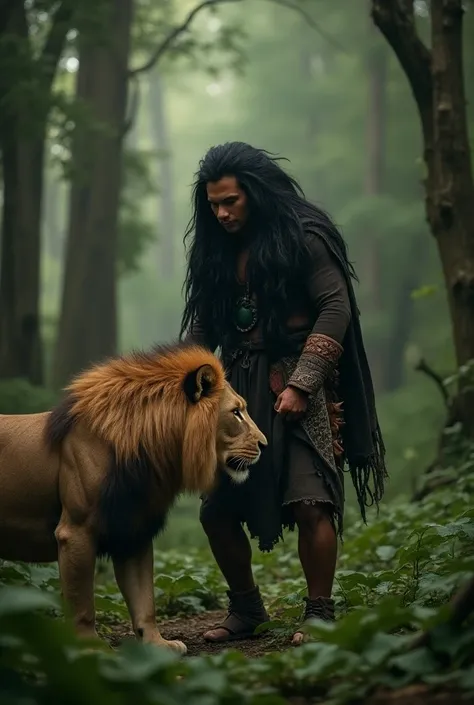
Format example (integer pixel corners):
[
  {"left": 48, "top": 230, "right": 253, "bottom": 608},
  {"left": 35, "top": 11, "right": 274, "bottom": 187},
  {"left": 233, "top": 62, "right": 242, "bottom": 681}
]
[{"left": 372, "top": 0, "right": 474, "bottom": 437}]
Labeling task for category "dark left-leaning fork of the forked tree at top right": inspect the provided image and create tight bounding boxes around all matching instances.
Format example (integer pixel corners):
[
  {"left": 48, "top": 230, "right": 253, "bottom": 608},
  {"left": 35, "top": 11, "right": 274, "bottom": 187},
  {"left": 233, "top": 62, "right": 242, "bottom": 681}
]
[{"left": 372, "top": 0, "right": 433, "bottom": 143}]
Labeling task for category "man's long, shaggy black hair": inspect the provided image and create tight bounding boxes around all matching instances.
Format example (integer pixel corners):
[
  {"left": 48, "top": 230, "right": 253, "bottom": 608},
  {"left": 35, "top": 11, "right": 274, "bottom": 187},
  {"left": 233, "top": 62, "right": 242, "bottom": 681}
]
[{"left": 181, "top": 142, "right": 355, "bottom": 344}]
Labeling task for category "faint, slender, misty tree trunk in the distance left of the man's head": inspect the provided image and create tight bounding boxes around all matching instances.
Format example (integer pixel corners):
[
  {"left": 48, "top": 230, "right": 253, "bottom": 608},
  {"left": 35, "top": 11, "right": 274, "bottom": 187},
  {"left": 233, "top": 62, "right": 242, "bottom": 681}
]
[{"left": 150, "top": 69, "right": 175, "bottom": 280}]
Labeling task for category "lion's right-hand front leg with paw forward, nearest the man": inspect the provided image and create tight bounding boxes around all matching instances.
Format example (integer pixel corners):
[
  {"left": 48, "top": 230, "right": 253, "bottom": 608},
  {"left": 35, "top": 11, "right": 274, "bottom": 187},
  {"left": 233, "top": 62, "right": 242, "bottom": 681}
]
[{"left": 113, "top": 542, "right": 187, "bottom": 654}]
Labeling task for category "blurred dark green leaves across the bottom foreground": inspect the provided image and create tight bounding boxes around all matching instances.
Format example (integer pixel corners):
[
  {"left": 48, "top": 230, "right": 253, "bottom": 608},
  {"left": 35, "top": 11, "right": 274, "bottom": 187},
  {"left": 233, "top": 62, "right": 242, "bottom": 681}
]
[{"left": 0, "top": 588, "right": 474, "bottom": 705}]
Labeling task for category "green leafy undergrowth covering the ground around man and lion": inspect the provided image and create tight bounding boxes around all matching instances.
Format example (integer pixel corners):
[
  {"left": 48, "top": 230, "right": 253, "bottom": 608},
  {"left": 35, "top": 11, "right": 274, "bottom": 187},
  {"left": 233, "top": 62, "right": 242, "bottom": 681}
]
[{"left": 0, "top": 452, "right": 474, "bottom": 705}]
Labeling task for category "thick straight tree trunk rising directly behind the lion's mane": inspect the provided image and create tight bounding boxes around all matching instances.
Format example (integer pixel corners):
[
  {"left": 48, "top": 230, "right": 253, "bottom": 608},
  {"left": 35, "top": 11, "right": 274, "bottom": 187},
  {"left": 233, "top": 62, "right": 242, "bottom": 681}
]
[{"left": 54, "top": 0, "right": 133, "bottom": 386}]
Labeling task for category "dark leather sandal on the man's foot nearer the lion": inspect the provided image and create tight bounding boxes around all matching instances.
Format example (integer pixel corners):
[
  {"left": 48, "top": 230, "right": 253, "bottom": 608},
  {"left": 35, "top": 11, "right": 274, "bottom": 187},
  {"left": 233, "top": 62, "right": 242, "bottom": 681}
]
[{"left": 204, "top": 587, "right": 270, "bottom": 644}]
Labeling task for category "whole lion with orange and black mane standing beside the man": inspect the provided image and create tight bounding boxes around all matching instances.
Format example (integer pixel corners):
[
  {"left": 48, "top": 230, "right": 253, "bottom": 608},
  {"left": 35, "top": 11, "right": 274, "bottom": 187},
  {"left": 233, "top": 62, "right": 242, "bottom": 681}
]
[{"left": 0, "top": 343, "right": 267, "bottom": 654}]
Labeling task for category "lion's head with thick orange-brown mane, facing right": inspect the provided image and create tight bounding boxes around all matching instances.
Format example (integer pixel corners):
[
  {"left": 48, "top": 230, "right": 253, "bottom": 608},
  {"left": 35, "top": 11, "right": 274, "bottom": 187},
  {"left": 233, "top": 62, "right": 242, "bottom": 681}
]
[{"left": 48, "top": 343, "right": 267, "bottom": 492}]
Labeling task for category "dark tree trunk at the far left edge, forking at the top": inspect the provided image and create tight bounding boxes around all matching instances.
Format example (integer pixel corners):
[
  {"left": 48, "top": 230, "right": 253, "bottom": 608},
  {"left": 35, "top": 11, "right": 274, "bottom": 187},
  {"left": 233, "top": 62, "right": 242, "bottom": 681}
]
[{"left": 0, "top": 0, "right": 72, "bottom": 384}]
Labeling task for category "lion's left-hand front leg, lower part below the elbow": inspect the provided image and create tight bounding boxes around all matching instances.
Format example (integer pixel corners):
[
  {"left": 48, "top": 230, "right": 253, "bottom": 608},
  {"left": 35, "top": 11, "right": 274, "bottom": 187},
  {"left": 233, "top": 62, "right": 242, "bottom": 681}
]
[{"left": 55, "top": 512, "right": 97, "bottom": 637}]
